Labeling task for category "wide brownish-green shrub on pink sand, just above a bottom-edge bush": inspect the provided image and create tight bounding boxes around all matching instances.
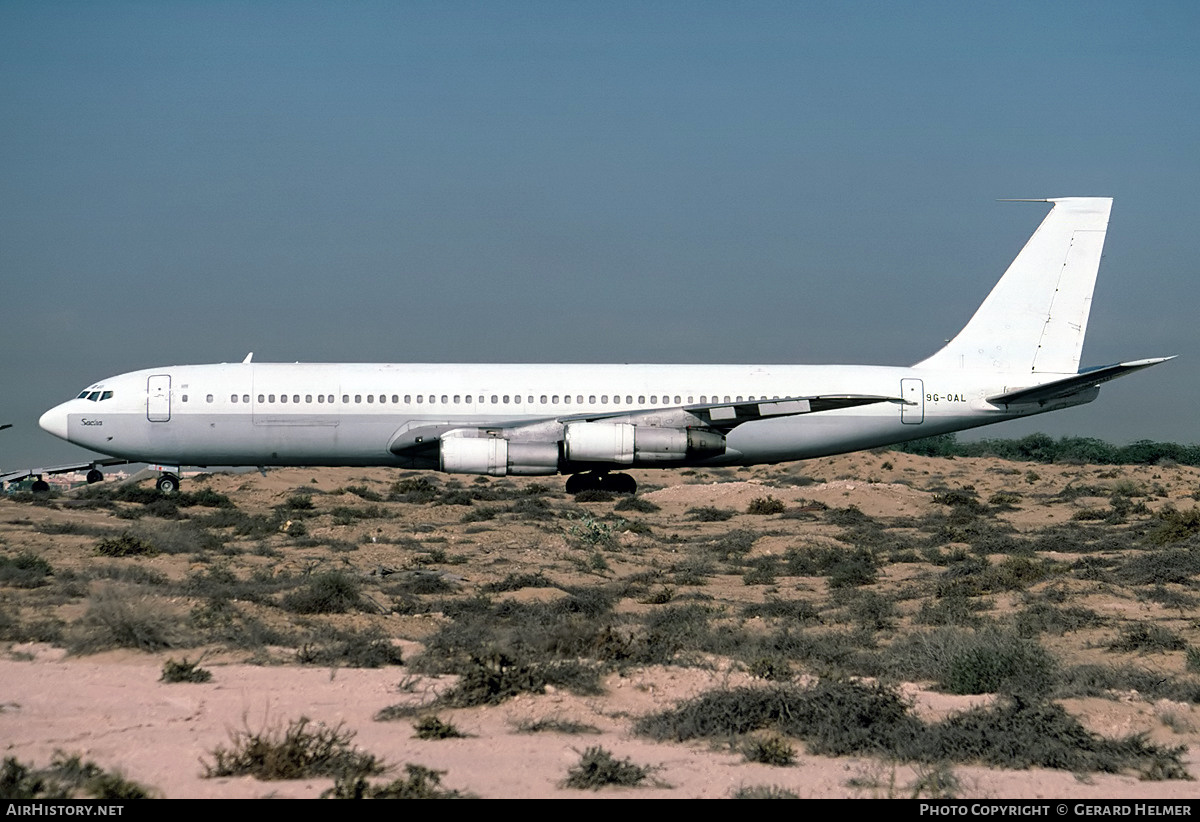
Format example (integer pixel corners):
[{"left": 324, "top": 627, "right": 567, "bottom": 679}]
[{"left": 203, "top": 716, "right": 385, "bottom": 780}]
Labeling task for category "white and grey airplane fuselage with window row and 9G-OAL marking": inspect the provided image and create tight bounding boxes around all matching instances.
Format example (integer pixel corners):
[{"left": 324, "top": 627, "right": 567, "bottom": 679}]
[{"left": 41, "top": 362, "right": 1097, "bottom": 473}]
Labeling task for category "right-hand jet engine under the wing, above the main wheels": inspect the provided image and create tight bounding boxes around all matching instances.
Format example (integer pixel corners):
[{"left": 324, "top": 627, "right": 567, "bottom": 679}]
[{"left": 564, "top": 422, "right": 725, "bottom": 466}]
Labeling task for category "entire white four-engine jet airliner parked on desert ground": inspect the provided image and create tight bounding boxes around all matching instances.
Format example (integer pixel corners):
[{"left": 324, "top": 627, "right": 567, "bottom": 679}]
[{"left": 40, "top": 197, "right": 1174, "bottom": 493}]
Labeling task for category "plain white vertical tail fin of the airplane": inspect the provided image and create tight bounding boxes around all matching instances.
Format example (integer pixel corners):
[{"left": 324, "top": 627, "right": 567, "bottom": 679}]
[{"left": 914, "top": 197, "right": 1112, "bottom": 374}]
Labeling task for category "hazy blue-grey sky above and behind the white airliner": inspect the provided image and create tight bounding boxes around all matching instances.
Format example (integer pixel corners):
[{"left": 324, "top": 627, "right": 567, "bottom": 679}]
[{"left": 0, "top": 0, "right": 1200, "bottom": 467}]
